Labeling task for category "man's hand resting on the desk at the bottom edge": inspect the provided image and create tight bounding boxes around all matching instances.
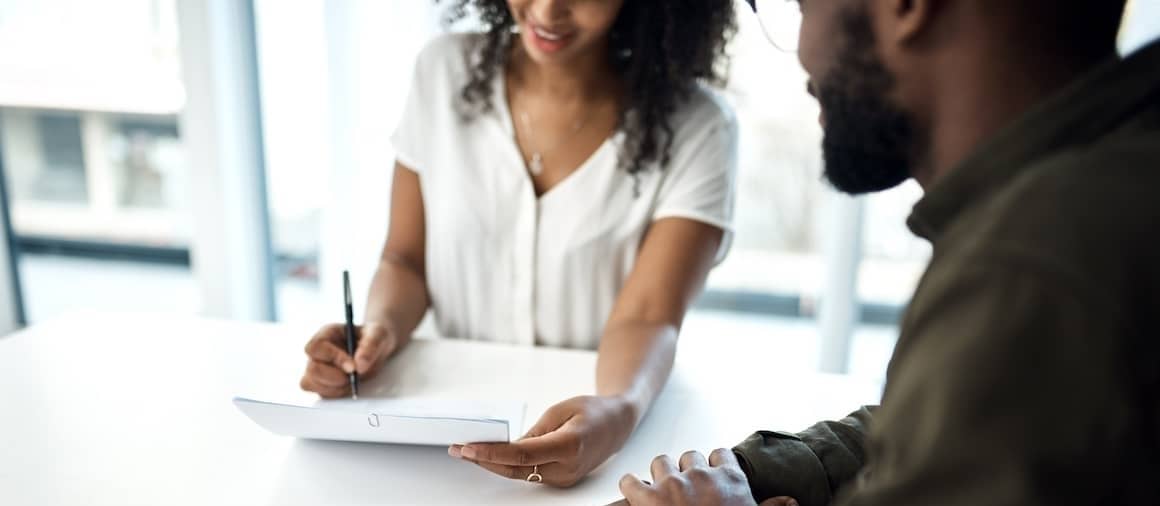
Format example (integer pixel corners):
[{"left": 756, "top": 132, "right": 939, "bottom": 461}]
[{"left": 621, "top": 449, "right": 797, "bottom": 506}]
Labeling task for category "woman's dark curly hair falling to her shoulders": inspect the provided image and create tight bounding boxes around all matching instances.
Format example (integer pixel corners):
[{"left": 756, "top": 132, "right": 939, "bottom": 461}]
[{"left": 436, "top": 0, "right": 737, "bottom": 176}]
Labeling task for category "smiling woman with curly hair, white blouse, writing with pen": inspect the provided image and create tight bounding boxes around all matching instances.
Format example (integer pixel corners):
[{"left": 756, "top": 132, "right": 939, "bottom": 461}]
[{"left": 302, "top": 0, "right": 737, "bottom": 486}]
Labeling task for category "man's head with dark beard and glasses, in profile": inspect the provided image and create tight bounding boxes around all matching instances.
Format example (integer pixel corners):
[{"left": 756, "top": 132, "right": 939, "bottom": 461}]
[{"left": 788, "top": 0, "right": 1124, "bottom": 194}]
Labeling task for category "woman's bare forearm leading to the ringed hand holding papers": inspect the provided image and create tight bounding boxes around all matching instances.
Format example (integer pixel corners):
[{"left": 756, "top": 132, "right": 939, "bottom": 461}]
[{"left": 596, "top": 321, "right": 677, "bottom": 428}]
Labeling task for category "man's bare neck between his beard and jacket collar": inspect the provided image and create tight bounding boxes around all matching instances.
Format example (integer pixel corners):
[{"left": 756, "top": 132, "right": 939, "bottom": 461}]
[{"left": 914, "top": 51, "right": 1111, "bottom": 189}]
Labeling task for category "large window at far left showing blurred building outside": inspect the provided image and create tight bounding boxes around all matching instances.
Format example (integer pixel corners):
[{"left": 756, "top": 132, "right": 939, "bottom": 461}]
[{"left": 0, "top": 0, "right": 197, "bottom": 323}]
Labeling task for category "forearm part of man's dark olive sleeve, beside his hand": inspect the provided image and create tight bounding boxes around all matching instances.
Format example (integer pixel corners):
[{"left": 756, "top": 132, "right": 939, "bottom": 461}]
[{"left": 733, "top": 406, "right": 875, "bottom": 506}]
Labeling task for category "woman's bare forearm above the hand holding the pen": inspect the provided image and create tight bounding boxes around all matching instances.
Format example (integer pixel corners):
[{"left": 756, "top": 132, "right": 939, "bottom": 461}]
[{"left": 365, "top": 253, "right": 429, "bottom": 339}]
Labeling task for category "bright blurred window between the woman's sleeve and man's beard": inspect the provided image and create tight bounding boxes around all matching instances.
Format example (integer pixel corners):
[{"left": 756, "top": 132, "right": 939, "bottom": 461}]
[{"left": 702, "top": 3, "right": 929, "bottom": 323}]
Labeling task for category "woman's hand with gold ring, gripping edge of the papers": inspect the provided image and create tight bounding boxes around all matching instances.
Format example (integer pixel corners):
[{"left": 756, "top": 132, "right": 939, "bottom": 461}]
[{"left": 448, "top": 396, "right": 637, "bottom": 486}]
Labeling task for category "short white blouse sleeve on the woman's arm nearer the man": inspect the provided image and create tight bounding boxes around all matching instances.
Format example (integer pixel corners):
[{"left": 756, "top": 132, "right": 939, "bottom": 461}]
[{"left": 652, "top": 91, "right": 738, "bottom": 263}]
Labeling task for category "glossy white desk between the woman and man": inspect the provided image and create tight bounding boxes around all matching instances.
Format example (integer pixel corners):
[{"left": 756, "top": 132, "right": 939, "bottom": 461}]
[{"left": 0, "top": 313, "right": 880, "bottom": 506}]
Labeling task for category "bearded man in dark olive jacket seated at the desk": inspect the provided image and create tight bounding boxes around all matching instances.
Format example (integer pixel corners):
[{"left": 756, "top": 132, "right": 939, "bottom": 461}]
[{"left": 621, "top": 0, "right": 1160, "bottom": 506}]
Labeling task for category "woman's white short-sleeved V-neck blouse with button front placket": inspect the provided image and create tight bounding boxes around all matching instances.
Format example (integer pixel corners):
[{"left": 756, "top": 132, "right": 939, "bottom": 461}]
[{"left": 391, "top": 34, "right": 737, "bottom": 349}]
